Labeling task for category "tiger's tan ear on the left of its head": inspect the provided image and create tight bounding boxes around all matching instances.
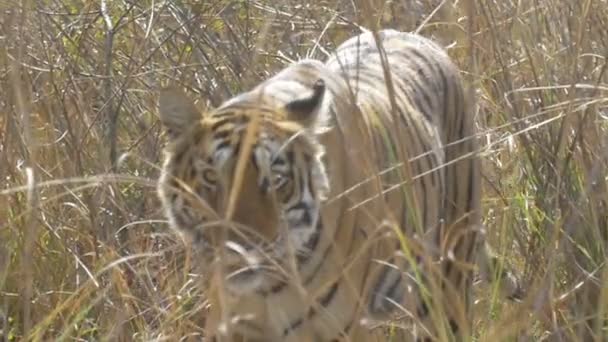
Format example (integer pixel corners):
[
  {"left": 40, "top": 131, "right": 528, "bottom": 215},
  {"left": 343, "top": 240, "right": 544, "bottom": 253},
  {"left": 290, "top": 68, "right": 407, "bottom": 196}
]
[{"left": 158, "top": 88, "right": 202, "bottom": 138}]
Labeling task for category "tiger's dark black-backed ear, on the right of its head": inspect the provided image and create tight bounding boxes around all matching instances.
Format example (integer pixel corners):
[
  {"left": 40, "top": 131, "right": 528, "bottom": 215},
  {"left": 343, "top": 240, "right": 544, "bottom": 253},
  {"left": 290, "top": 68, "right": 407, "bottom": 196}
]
[{"left": 285, "top": 79, "right": 325, "bottom": 127}]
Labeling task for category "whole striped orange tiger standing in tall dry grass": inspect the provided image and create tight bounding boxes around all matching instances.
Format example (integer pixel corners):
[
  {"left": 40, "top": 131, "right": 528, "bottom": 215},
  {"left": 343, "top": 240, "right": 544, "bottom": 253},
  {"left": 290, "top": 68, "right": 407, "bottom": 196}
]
[{"left": 158, "top": 29, "right": 524, "bottom": 342}]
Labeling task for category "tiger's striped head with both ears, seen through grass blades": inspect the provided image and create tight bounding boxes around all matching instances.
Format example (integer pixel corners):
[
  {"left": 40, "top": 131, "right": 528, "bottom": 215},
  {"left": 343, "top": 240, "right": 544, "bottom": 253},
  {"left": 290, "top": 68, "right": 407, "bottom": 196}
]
[{"left": 158, "top": 71, "right": 328, "bottom": 293}]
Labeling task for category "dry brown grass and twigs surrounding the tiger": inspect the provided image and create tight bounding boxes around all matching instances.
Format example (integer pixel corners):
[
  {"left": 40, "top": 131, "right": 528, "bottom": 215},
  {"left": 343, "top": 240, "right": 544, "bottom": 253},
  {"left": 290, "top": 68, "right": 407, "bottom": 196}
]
[{"left": 0, "top": 0, "right": 608, "bottom": 341}]
